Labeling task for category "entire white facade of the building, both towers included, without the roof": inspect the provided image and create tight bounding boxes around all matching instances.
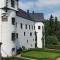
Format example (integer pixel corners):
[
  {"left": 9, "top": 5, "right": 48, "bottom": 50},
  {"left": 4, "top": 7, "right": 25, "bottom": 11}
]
[{"left": 0, "top": 0, "right": 44, "bottom": 57}]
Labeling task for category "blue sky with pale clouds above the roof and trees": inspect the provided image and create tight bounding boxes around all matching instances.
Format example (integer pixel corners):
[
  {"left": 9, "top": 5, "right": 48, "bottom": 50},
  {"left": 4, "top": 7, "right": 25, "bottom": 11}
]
[{"left": 19, "top": 0, "right": 60, "bottom": 19}]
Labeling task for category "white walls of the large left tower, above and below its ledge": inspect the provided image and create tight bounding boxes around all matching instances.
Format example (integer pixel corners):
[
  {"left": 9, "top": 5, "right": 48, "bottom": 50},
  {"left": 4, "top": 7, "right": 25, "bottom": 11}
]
[{"left": 0, "top": 0, "right": 17, "bottom": 57}]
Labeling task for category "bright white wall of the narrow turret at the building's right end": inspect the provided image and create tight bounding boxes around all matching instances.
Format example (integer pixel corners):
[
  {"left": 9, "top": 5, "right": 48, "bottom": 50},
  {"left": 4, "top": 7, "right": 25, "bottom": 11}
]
[{"left": 35, "top": 22, "right": 44, "bottom": 48}]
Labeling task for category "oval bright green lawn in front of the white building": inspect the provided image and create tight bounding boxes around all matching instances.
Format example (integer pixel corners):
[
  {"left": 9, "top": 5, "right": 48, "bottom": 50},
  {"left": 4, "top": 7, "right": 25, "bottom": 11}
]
[{"left": 22, "top": 49, "right": 60, "bottom": 60}]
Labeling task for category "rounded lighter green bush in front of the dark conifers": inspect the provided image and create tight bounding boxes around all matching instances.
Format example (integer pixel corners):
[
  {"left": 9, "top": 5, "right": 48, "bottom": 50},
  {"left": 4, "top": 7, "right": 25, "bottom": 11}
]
[{"left": 46, "top": 36, "right": 59, "bottom": 47}]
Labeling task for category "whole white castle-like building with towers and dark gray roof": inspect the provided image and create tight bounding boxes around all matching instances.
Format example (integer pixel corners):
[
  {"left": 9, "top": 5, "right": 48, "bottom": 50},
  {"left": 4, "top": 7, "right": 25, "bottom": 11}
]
[{"left": 0, "top": 0, "right": 44, "bottom": 57}]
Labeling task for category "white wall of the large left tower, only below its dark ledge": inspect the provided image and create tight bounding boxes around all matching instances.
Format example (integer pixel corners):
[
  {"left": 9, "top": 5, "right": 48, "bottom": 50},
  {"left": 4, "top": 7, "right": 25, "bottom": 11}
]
[{"left": 0, "top": 10, "right": 16, "bottom": 57}]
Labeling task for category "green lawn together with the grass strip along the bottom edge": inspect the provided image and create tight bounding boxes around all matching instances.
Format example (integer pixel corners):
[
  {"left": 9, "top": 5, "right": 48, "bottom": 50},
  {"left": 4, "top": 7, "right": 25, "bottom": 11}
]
[{"left": 2, "top": 48, "right": 60, "bottom": 60}]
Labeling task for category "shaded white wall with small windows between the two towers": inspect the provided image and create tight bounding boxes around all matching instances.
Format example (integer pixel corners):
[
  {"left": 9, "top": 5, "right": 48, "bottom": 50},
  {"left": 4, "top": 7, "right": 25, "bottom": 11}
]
[{"left": 16, "top": 17, "right": 35, "bottom": 49}]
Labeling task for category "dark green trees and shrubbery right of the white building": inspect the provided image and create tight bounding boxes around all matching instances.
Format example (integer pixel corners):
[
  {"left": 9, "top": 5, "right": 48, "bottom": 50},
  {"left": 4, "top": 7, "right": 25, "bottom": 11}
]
[{"left": 44, "top": 15, "right": 60, "bottom": 47}]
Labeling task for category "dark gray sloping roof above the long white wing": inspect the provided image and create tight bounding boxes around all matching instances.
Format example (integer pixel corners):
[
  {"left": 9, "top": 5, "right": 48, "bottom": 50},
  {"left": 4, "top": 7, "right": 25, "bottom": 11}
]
[{"left": 16, "top": 9, "right": 44, "bottom": 22}]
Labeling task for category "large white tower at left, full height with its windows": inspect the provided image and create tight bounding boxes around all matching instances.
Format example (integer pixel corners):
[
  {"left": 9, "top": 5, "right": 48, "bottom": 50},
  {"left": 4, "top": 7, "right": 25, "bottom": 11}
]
[{"left": 0, "top": 0, "right": 18, "bottom": 57}]
